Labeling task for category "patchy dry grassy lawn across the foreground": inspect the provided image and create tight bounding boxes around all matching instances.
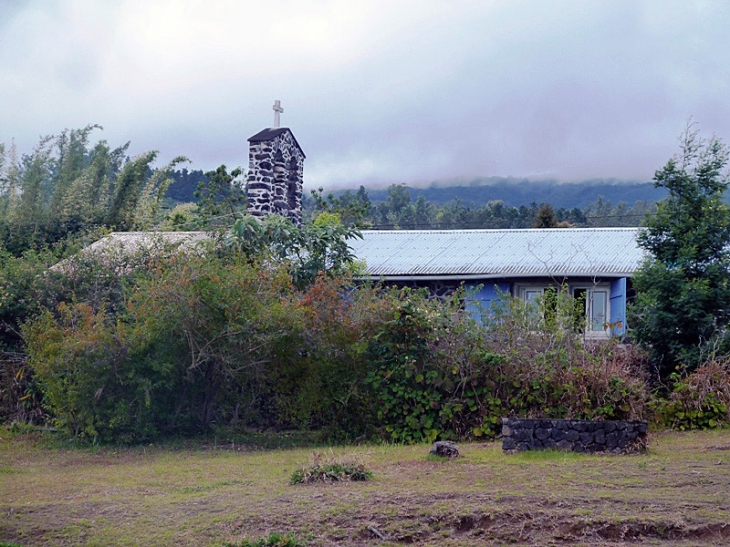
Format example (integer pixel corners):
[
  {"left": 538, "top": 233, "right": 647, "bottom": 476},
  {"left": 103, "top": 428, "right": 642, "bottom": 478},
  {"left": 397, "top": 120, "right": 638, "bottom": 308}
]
[{"left": 0, "top": 430, "right": 730, "bottom": 546}]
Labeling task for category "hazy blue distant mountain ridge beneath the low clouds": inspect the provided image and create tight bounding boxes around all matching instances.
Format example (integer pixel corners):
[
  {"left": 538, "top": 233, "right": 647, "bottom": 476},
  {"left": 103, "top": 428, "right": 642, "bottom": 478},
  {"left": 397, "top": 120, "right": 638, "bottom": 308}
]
[{"left": 356, "top": 177, "right": 667, "bottom": 209}]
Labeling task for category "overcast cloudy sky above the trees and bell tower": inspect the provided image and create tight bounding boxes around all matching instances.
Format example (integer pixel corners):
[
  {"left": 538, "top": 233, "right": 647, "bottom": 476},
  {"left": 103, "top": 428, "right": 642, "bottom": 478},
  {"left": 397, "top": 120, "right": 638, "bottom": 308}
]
[{"left": 0, "top": 0, "right": 730, "bottom": 188}]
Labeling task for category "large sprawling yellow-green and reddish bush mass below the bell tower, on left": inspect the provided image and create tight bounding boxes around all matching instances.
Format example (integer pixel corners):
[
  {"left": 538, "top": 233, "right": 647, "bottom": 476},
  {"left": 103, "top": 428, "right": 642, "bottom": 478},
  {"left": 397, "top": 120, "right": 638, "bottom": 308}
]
[{"left": 24, "top": 246, "right": 382, "bottom": 442}]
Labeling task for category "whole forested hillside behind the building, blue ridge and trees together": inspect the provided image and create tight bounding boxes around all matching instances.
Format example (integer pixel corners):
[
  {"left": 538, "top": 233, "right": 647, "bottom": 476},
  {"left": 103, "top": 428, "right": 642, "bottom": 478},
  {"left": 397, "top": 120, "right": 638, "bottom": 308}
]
[{"left": 167, "top": 173, "right": 666, "bottom": 230}]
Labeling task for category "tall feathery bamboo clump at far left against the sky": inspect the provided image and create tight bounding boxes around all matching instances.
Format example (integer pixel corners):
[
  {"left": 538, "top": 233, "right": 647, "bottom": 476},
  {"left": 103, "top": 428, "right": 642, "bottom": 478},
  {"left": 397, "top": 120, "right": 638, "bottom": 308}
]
[{"left": 0, "top": 125, "right": 185, "bottom": 256}]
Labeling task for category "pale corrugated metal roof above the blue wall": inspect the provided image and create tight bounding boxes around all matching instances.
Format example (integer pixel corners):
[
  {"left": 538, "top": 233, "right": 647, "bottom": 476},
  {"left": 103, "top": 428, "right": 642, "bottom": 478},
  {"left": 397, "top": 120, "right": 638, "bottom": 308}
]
[{"left": 349, "top": 228, "right": 644, "bottom": 278}]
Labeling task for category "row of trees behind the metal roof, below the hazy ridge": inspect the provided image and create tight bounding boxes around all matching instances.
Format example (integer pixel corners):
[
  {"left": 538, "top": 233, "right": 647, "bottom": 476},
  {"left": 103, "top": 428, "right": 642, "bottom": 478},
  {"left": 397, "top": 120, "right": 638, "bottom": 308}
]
[{"left": 305, "top": 184, "right": 656, "bottom": 230}]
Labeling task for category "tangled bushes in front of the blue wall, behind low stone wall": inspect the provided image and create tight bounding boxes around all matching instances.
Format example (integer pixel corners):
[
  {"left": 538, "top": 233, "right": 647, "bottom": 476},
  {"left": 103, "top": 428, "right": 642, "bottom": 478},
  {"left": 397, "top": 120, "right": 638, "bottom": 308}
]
[{"left": 367, "top": 291, "right": 648, "bottom": 442}]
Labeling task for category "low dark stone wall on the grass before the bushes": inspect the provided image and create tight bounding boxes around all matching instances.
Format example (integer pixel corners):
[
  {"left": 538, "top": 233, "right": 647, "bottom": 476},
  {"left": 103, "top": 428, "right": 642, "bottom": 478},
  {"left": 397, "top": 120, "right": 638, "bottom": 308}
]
[{"left": 502, "top": 418, "right": 649, "bottom": 454}]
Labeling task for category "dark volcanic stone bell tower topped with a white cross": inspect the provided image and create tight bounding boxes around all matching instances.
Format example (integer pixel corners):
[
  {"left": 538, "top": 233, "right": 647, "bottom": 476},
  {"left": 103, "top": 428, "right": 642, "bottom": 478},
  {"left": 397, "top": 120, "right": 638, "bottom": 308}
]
[{"left": 246, "top": 101, "right": 305, "bottom": 225}]
